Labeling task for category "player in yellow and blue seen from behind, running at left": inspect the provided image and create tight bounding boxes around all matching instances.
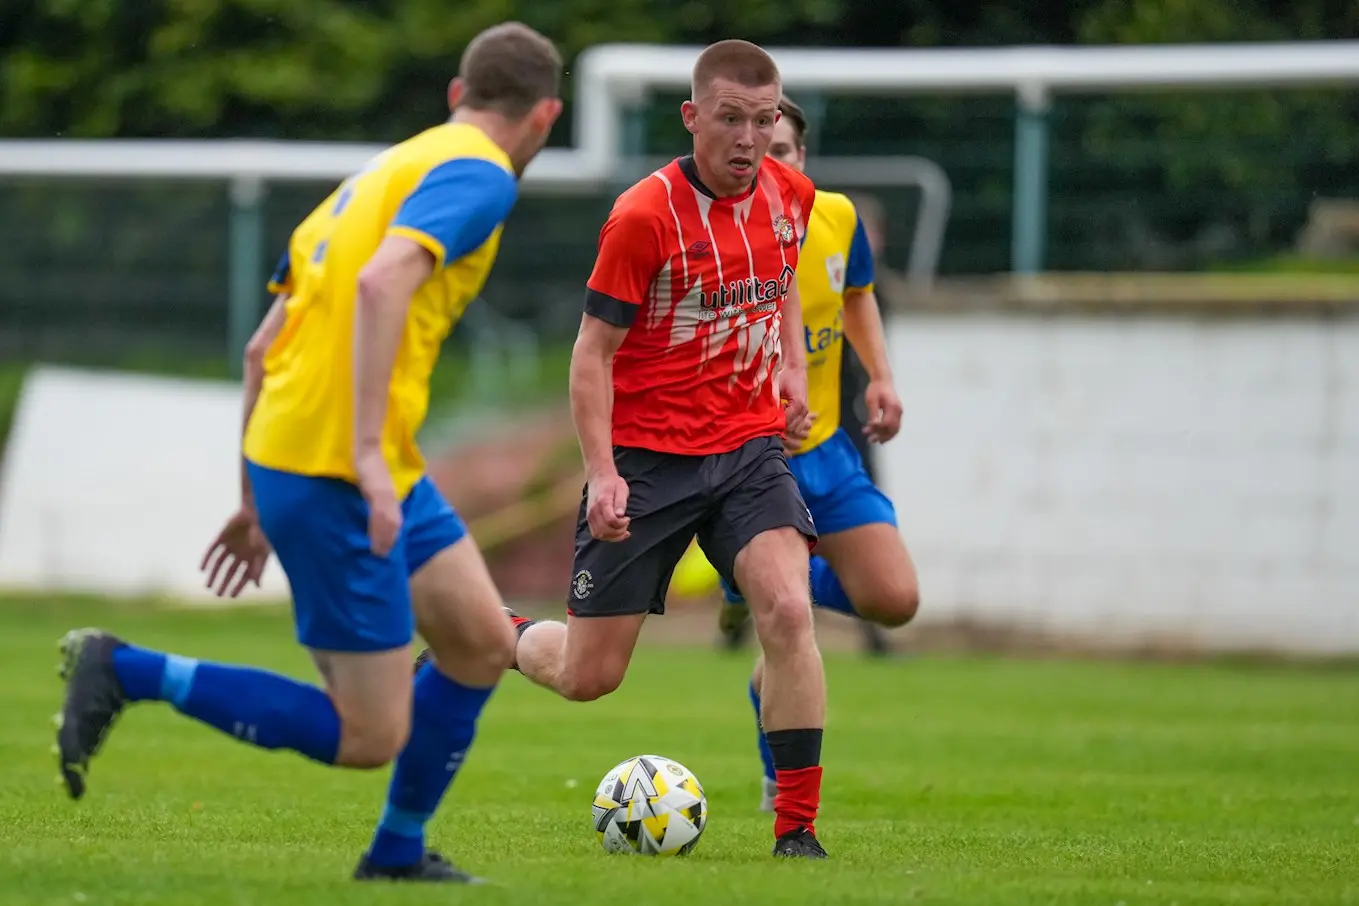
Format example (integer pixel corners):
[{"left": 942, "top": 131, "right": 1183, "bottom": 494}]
[{"left": 51, "top": 23, "right": 561, "bottom": 882}]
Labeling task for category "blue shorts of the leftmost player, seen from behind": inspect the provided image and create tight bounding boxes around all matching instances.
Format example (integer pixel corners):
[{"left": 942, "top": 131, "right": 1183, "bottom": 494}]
[{"left": 246, "top": 462, "right": 467, "bottom": 652}]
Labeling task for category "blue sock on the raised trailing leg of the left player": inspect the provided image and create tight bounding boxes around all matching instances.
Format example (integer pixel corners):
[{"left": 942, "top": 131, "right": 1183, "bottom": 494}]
[{"left": 113, "top": 645, "right": 340, "bottom": 765}]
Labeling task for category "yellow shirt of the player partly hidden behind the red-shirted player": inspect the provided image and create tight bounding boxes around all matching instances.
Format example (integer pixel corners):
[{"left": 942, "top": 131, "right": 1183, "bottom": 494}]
[{"left": 798, "top": 189, "right": 872, "bottom": 454}]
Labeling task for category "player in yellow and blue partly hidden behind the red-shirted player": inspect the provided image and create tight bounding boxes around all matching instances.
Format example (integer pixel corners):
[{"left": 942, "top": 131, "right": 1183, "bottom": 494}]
[{"left": 719, "top": 98, "right": 920, "bottom": 811}]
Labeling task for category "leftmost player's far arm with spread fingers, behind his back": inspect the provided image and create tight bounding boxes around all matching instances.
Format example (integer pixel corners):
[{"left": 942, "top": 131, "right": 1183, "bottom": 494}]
[{"left": 198, "top": 293, "right": 288, "bottom": 598}]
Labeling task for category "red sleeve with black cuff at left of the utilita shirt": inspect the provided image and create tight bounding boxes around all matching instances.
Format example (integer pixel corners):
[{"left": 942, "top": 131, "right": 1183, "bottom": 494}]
[{"left": 586, "top": 205, "right": 665, "bottom": 327}]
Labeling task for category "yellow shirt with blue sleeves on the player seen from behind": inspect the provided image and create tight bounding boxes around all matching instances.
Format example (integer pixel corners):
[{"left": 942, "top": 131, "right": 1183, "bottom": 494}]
[{"left": 243, "top": 124, "right": 518, "bottom": 499}]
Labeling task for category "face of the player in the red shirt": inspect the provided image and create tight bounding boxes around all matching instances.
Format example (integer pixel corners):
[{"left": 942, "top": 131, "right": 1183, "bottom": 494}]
[{"left": 681, "top": 79, "right": 779, "bottom": 196}]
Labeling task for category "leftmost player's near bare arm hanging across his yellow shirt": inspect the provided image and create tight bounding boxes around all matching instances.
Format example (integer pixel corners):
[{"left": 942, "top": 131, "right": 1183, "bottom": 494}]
[{"left": 353, "top": 236, "right": 435, "bottom": 557}]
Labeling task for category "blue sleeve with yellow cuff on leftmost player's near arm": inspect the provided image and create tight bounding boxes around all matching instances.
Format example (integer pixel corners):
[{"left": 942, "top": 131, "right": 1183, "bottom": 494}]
[{"left": 387, "top": 158, "right": 519, "bottom": 268}]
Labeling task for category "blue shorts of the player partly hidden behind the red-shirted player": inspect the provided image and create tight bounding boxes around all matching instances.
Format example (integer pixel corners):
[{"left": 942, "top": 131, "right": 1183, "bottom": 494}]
[{"left": 788, "top": 428, "right": 897, "bottom": 535}]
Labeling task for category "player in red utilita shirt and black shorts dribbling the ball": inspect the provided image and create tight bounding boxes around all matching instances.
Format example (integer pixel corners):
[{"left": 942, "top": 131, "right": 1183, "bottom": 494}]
[{"left": 515, "top": 41, "right": 826, "bottom": 858}]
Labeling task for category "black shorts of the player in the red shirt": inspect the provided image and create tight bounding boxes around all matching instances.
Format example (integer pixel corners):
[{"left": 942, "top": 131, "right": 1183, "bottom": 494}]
[{"left": 567, "top": 437, "right": 817, "bottom": 617}]
